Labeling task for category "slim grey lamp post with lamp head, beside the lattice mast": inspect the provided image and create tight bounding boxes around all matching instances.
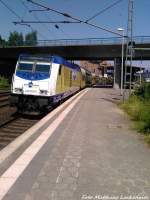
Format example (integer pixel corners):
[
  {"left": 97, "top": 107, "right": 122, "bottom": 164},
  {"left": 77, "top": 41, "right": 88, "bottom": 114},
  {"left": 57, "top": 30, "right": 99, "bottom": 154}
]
[{"left": 117, "top": 28, "right": 124, "bottom": 95}]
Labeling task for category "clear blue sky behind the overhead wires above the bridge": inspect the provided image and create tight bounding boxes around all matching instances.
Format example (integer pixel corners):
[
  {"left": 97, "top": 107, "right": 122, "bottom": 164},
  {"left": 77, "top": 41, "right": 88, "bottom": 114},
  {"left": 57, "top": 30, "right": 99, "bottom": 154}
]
[{"left": 0, "top": 0, "right": 150, "bottom": 39}]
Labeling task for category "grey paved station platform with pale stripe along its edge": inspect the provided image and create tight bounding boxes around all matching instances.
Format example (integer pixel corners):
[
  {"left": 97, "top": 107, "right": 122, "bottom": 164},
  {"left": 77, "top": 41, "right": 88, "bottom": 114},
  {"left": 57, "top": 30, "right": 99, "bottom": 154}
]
[{"left": 0, "top": 88, "right": 150, "bottom": 200}]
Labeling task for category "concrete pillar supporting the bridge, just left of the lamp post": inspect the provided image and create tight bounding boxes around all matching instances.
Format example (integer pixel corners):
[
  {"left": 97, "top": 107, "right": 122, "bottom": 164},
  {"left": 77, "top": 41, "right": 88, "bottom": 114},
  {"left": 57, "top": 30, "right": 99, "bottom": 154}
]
[{"left": 113, "top": 58, "right": 121, "bottom": 89}]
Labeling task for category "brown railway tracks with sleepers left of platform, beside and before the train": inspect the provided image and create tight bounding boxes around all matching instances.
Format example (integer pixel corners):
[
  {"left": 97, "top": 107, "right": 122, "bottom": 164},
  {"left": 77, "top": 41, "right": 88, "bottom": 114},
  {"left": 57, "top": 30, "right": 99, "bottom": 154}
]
[{"left": 0, "top": 91, "right": 49, "bottom": 150}]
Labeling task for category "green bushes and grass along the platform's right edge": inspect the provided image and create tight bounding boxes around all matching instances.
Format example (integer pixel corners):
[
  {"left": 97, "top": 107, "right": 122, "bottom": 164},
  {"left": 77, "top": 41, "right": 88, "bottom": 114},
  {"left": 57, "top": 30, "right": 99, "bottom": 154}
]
[{"left": 122, "top": 83, "right": 150, "bottom": 135}]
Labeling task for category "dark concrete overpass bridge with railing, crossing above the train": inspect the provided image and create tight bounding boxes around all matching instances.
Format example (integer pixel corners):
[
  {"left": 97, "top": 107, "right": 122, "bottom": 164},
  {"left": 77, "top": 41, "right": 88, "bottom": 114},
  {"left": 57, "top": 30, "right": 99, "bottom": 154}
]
[{"left": 0, "top": 36, "right": 150, "bottom": 87}]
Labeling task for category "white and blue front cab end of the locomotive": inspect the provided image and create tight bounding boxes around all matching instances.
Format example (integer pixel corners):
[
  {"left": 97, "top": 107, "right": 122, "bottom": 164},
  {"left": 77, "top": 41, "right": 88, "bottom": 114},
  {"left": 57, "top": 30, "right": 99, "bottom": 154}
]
[{"left": 10, "top": 56, "right": 51, "bottom": 112}]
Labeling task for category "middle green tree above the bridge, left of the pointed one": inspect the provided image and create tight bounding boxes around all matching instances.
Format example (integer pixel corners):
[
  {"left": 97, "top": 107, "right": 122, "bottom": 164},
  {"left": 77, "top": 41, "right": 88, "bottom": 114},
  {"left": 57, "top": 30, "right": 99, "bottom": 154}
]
[{"left": 8, "top": 31, "right": 24, "bottom": 46}]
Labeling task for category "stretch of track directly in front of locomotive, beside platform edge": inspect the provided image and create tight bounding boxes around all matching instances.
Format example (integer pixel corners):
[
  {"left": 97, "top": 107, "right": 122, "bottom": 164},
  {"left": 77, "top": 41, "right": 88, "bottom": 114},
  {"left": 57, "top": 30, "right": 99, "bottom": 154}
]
[{"left": 0, "top": 114, "right": 39, "bottom": 150}]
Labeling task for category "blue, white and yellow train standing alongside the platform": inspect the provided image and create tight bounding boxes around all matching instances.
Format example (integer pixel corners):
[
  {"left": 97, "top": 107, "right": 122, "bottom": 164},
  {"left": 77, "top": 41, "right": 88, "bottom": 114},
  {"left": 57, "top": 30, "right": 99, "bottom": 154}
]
[{"left": 10, "top": 55, "right": 96, "bottom": 114}]
